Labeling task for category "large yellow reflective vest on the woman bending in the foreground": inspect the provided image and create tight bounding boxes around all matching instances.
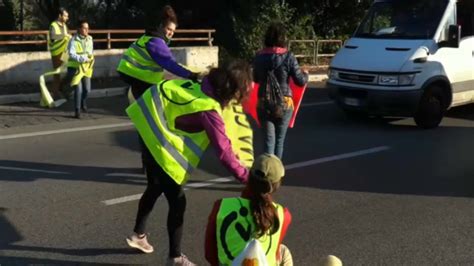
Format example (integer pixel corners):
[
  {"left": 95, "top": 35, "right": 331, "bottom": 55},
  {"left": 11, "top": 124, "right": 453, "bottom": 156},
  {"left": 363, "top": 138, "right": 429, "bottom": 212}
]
[{"left": 126, "top": 80, "right": 221, "bottom": 185}]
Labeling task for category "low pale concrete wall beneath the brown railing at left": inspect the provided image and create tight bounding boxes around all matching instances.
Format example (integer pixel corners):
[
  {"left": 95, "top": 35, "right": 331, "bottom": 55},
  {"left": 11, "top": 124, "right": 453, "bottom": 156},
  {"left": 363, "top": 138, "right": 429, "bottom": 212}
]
[{"left": 0, "top": 46, "right": 219, "bottom": 85}]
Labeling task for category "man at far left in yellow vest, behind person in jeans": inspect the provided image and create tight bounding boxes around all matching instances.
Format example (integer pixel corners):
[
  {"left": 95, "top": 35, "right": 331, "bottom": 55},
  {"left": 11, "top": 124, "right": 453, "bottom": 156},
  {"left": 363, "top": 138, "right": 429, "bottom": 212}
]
[{"left": 48, "top": 7, "right": 71, "bottom": 99}]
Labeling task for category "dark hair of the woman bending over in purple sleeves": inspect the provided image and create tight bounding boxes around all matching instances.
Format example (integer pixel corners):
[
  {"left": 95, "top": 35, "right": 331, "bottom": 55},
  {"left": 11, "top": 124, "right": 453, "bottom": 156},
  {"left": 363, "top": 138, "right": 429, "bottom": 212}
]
[{"left": 208, "top": 60, "right": 252, "bottom": 106}]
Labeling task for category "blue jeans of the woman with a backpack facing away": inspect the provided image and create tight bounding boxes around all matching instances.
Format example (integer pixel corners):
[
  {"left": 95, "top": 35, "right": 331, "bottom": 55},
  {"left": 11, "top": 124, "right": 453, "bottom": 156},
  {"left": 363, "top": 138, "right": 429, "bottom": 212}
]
[{"left": 257, "top": 108, "right": 293, "bottom": 159}]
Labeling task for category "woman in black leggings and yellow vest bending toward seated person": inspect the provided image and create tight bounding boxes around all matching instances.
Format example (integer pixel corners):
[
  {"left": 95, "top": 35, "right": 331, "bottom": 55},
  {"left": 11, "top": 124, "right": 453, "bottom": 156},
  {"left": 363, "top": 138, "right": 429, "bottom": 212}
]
[{"left": 126, "top": 61, "right": 251, "bottom": 265}]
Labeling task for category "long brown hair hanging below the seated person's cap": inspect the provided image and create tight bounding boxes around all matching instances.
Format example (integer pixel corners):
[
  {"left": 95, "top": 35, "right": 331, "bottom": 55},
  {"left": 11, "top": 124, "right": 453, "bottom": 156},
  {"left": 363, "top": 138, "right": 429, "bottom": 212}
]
[{"left": 248, "top": 174, "right": 281, "bottom": 238}]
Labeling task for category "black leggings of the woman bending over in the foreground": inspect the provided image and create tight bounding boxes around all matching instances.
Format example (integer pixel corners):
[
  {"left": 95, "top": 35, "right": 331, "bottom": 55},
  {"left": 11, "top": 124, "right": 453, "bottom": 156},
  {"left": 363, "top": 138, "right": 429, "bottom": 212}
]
[{"left": 134, "top": 146, "right": 186, "bottom": 258}]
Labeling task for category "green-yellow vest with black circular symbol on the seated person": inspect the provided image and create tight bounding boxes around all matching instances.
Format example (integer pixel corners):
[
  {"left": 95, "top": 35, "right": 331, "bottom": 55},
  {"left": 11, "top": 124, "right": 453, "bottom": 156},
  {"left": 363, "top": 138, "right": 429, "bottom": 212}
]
[{"left": 216, "top": 198, "right": 284, "bottom": 266}]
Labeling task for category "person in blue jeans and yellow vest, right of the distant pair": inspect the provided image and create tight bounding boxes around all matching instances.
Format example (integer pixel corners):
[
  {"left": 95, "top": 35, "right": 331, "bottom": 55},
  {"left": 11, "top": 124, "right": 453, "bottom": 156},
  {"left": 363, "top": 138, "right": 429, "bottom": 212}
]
[{"left": 66, "top": 20, "right": 94, "bottom": 118}]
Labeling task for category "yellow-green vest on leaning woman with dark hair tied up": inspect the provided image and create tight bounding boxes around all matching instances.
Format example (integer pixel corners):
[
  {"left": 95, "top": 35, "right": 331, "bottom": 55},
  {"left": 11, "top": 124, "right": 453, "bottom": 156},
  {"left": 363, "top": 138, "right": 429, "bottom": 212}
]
[{"left": 117, "top": 35, "right": 164, "bottom": 84}]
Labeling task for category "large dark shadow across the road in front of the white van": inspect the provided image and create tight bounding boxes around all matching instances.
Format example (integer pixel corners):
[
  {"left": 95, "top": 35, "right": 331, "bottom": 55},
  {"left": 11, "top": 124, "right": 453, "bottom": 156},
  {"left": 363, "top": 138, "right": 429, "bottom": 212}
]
[{"left": 284, "top": 120, "right": 474, "bottom": 197}]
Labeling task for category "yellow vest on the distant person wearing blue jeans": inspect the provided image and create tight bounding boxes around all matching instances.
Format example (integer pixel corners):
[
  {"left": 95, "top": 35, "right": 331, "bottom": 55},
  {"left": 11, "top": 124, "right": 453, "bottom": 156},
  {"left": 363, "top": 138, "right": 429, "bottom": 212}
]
[{"left": 67, "top": 35, "right": 95, "bottom": 86}]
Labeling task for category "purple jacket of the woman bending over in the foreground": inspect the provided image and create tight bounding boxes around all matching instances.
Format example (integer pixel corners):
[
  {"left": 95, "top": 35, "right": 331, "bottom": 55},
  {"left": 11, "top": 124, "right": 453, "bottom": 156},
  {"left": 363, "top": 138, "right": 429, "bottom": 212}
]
[{"left": 176, "top": 78, "right": 249, "bottom": 183}]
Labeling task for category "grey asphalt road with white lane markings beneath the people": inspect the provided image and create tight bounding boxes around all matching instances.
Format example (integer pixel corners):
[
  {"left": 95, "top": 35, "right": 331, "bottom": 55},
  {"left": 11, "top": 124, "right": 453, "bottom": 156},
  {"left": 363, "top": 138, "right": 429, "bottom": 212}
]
[{"left": 0, "top": 89, "right": 474, "bottom": 265}]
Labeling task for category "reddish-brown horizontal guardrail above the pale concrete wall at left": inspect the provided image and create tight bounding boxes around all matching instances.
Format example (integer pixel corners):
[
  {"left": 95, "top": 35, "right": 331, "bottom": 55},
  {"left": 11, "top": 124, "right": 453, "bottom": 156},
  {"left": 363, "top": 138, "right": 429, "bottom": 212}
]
[{"left": 0, "top": 29, "right": 216, "bottom": 49}]
